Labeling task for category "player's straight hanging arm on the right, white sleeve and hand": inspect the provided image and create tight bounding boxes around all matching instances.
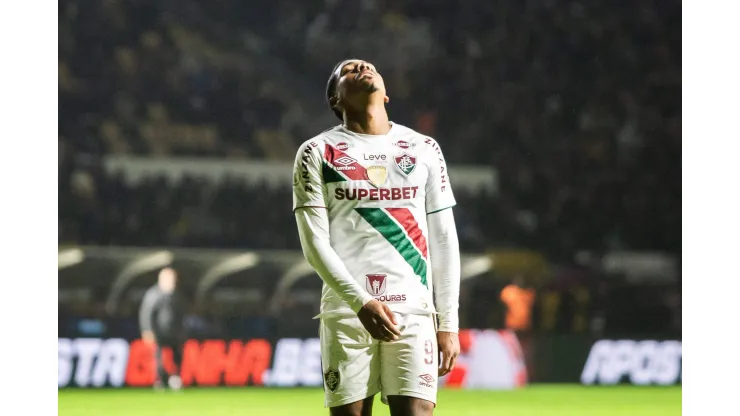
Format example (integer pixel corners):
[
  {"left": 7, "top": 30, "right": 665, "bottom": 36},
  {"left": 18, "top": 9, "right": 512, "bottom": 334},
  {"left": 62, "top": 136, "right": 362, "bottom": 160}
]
[{"left": 426, "top": 137, "right": 460, "bottom": 376}]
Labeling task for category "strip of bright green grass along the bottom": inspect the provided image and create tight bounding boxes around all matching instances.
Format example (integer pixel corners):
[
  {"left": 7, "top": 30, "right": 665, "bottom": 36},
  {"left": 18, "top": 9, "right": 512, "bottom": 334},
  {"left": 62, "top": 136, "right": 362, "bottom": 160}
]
[{"left": 59, "top": 385, "right": 681, "bottom": 416}]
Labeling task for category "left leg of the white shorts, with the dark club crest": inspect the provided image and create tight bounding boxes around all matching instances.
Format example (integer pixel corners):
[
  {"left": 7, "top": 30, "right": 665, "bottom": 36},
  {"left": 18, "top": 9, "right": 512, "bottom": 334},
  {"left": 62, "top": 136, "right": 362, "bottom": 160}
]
[{"left": 319, "top": 317, "right": 380, "bottom": 407}]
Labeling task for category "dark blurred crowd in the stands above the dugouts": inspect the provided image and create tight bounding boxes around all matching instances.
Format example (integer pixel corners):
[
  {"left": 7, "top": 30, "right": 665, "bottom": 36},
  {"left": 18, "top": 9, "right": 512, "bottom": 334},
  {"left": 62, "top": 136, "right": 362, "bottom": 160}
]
[{"left": 59, "top": 0, "right": 681, "bottom": 257}]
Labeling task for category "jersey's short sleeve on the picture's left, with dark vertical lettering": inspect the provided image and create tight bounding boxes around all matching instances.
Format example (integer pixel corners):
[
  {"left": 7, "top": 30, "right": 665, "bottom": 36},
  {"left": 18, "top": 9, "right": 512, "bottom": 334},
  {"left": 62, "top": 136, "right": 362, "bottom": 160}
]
[{"left": 293, "top": 139, "right": 326, "bottom": 211}]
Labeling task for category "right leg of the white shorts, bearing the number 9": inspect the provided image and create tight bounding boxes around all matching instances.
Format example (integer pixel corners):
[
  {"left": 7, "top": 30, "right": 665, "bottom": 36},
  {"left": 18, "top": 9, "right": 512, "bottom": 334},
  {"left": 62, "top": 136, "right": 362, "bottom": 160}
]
[{"left": 380, "top": 315, "right": 438, "bottom": 407}]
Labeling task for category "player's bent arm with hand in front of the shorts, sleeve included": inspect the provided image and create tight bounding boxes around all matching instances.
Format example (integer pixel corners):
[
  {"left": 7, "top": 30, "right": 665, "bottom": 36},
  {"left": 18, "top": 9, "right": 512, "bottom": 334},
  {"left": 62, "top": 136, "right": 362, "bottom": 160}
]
[{"left": 293, "top": 141, "right": 400, "bottom": 341}]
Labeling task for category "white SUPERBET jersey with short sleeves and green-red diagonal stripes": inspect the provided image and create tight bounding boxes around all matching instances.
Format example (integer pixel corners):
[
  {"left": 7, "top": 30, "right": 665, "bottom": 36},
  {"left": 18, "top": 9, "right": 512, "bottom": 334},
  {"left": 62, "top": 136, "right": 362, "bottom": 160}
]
[{"left": 293, "top": 123, "right": 455, "bottom": 314}]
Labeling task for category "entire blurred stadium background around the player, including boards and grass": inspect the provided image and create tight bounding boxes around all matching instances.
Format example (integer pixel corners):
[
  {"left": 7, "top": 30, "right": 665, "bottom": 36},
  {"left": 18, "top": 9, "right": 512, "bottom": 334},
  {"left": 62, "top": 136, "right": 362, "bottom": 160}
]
[{"left": 59, "top": 0, "right": 681, "bottom": 416}]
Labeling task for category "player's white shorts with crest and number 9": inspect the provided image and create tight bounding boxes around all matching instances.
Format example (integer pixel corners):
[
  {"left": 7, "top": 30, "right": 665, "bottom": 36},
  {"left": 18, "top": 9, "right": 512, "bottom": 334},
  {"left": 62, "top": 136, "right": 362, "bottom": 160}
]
[{"left": 319, "top": 313, "right": 438, "bottom": 407}]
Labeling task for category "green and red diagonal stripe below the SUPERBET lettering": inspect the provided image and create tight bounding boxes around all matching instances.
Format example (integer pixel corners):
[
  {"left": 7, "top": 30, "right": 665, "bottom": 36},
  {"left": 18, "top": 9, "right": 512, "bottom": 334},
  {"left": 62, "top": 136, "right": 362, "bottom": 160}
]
[{"left": 355, "top": 208, "right": 427, "bottom": 286}]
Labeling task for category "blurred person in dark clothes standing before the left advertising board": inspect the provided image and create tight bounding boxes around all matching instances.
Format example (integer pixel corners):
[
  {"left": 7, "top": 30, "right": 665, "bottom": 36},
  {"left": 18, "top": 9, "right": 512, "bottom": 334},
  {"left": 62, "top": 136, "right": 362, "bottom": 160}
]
[{"left": 139, "top": 267, "right": 186, "bottom": 390}]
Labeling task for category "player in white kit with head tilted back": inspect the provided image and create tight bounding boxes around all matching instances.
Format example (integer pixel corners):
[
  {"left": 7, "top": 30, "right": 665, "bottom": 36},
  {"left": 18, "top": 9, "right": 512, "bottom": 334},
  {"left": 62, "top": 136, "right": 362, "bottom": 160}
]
[{"left": 293, "top": 59, "right": 460, "bottom": 416}]
